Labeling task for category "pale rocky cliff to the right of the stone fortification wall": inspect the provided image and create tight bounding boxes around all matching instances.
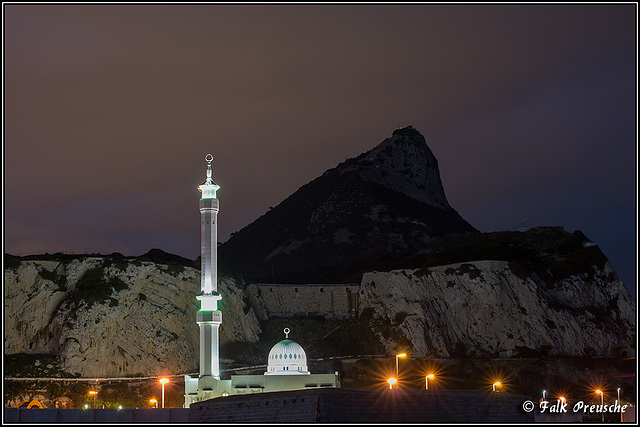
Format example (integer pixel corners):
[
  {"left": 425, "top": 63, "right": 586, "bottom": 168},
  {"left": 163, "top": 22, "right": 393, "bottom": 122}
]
[{"left": 359, "top": 261, "right": 635, "bottom": 357}]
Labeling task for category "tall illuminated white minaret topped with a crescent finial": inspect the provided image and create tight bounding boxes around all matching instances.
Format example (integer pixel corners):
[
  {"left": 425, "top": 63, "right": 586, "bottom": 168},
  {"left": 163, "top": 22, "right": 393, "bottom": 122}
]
[{"left": 196, "top": 154, "right": 222, "bottom": 393}]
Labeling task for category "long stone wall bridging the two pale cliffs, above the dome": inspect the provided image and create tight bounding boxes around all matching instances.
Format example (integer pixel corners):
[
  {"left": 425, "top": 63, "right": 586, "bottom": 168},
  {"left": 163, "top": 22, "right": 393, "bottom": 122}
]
[{"left": 245, "top": 283, "right": 360, "bottom": 320}]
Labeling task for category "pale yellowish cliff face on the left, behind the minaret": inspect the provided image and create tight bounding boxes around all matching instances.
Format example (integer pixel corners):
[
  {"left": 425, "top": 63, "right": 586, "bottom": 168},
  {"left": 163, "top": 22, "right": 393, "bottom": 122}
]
[{"left": 4, "top": 257, "right": 259, "bottom": 377}]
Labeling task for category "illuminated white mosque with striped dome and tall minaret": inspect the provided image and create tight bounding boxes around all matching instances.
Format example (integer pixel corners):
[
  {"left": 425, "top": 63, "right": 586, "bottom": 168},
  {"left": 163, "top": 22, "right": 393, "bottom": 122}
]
[{"left": 184, "top": 154, "right": 340, "bottom": 408}]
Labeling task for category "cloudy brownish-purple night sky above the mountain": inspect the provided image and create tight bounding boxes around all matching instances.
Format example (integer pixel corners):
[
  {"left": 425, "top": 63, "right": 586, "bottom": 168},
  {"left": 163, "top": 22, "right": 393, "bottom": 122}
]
[{"left": 3, "top": 4, "right": 637, "bottom": 295}]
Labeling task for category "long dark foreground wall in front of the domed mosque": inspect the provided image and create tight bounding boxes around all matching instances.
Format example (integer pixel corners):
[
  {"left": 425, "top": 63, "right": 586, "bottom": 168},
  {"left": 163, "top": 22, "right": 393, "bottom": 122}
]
[{"left": 189, "top": 389, "right": 534, "bottom": 423}]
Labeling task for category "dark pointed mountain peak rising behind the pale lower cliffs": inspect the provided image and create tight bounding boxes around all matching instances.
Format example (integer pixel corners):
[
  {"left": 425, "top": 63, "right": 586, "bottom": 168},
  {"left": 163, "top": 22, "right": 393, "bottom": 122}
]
[{"left": 218, "top": 128, "right": 477, "bottom": 283}]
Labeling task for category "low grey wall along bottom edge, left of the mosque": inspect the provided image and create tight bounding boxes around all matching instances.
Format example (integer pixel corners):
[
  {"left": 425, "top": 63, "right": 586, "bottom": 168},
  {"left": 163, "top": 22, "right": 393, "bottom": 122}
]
[{"left": 3, "top": 408, "right": 189, "bottom": 423}]
